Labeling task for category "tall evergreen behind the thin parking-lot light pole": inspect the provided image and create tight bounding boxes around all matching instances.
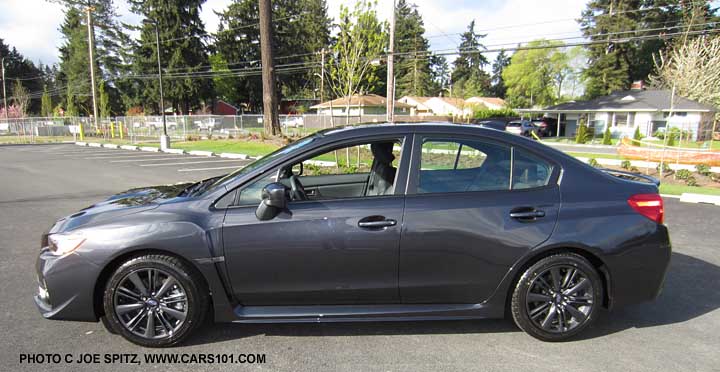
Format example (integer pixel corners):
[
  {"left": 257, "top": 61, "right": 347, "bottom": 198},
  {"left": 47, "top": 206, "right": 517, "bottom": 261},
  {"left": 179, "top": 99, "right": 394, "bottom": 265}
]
[{"left": 130, "top": 0, "right": 213, "bottom": 114}]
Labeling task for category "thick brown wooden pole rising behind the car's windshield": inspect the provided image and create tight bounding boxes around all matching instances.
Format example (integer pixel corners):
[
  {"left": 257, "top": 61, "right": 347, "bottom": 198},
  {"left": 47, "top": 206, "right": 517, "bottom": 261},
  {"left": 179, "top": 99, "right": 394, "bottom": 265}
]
[{"left": 259, "top": 0, "right": 280, "bottom": 136}]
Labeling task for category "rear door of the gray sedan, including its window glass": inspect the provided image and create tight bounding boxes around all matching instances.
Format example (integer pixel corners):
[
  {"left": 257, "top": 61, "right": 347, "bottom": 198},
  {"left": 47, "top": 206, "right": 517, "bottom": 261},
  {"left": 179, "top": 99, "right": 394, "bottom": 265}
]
[{"left": 399, "top": 135, "right": 560, "bottom": 303}]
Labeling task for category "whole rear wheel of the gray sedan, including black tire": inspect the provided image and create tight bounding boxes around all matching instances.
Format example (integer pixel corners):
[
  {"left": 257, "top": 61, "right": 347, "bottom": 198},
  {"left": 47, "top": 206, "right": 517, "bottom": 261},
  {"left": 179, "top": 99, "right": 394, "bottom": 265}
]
[{"left": 511, "top": 253, "right": 603, "bottom": 341}]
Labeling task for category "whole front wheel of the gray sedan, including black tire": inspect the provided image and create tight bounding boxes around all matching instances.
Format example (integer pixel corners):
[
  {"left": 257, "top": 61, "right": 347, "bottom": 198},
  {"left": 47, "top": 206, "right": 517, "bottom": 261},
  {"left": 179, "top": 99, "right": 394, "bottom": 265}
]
[{"left": 103, "top": 255, "right": 208, "bottom": 347}]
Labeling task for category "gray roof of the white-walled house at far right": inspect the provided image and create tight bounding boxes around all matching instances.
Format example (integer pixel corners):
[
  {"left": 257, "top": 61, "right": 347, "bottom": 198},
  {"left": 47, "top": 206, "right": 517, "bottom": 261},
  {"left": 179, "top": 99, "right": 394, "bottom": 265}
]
[{"left": 540, "top": 89, "right": 717, "bottom": 112}]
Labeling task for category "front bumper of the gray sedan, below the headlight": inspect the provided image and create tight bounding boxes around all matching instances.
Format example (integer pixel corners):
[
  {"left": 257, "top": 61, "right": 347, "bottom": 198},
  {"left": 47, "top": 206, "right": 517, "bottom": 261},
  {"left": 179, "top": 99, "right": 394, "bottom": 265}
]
[{"left": 34, "top": 248, "right": 100, "bottom": 322}]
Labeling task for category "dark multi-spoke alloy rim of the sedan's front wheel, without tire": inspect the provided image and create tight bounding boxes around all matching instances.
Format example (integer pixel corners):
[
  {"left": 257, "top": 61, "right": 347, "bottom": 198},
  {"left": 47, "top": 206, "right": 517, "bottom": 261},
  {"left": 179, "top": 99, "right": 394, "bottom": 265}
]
[{"left": 113, "top": 268, "right": 188, "bottom": 339}]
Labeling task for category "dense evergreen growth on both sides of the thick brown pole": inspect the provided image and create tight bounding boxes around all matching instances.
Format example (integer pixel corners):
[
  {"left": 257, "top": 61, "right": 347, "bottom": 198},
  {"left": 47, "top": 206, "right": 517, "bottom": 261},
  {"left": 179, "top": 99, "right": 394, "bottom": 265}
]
[{"left": 213, "top": 0, "right": 331, "bottom": 110}]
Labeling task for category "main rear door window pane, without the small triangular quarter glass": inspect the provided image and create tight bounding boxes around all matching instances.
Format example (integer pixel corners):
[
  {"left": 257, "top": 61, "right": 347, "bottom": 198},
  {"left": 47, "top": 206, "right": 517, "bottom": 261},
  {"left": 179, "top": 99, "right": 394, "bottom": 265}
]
[{"left": 417, "top": 139, "right": 510, "bottom": 194}]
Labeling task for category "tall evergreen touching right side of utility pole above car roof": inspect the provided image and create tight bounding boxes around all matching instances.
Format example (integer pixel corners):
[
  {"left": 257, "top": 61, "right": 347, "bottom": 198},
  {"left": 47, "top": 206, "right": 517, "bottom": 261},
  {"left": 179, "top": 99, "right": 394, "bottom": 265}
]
[{"left": 395, "top": 0, "right": 433, "bottom": 97}]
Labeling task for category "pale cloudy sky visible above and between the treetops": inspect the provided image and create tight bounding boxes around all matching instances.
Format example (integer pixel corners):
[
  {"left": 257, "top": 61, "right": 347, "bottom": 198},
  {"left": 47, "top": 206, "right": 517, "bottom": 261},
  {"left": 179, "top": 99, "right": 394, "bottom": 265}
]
[{"left": 0, "top": 0, "right": 587, "bottom": 64}]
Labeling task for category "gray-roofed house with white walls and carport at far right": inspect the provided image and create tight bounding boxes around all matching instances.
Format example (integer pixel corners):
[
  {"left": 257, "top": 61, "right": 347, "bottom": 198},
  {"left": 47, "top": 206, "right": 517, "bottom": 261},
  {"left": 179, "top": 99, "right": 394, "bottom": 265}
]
[{"left": 516, "top": 85, "right": 717, "bottom": 140}]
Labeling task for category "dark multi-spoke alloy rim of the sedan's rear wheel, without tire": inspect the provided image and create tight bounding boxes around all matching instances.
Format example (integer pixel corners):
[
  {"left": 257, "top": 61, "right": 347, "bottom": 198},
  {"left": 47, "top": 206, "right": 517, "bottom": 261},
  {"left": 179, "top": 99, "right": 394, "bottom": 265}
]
[{"left": 525, "top": 265, "right": 595, "bottom": 333}]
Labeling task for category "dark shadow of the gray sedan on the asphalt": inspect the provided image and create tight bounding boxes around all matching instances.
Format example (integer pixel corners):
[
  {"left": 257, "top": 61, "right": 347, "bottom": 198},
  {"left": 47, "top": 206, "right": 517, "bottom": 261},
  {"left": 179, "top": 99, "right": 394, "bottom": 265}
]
[{"left": 186, "top": 253, "right": 720, "bottom": 345}]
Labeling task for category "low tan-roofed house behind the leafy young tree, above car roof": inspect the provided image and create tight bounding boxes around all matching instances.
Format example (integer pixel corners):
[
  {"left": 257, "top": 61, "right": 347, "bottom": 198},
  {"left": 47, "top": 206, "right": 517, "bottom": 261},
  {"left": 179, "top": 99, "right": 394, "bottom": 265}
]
[{"left": 310, "top": 94, "right": 411, "bottom": 116}]
